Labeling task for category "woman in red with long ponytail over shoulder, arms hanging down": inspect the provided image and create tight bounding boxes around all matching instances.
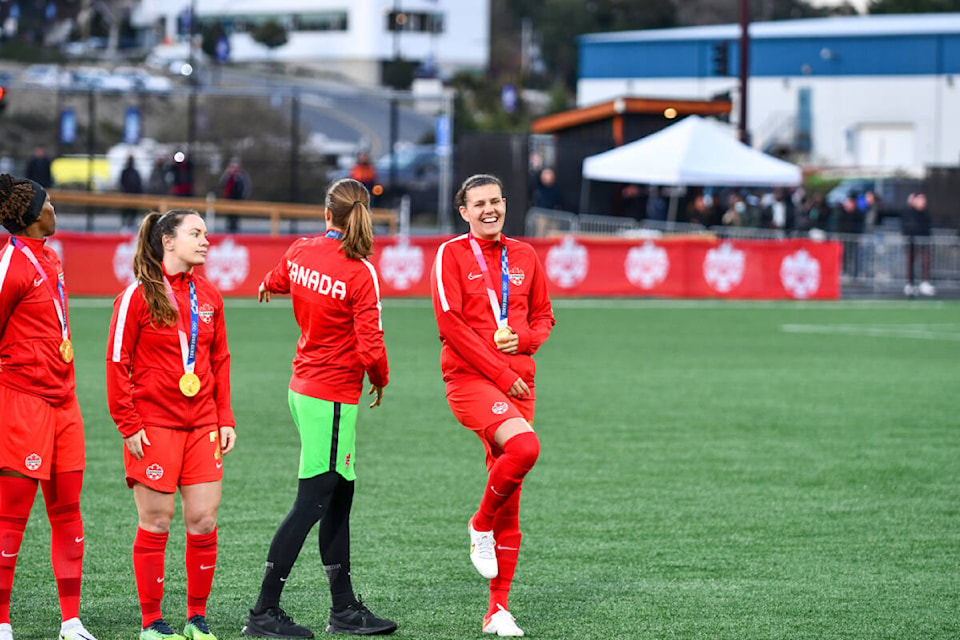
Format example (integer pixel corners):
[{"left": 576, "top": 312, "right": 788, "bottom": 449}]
[{"left": 107, "top": 210, "right": 236, "bottom": 640}]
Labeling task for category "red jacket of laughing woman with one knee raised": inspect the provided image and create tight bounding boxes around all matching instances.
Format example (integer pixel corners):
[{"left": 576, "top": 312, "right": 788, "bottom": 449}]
[{"left": 430, "top": 234, "right": 556, "bottom": 391}]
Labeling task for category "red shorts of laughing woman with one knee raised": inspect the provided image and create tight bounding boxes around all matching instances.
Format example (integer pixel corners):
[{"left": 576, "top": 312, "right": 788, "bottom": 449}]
[{"left": 447, "top": 376, "right": 536, "bottom": 468}]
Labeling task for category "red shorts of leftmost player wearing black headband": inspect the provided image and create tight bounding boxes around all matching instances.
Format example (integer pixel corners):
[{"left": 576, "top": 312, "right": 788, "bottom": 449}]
[{"left": 0, "top": 385, "right": 87, "bottom": 480}]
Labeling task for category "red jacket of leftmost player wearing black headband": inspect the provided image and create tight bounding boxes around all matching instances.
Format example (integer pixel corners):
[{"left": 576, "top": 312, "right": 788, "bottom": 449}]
[{"left": 0, "top": 236, "right": 76, "bottom": 406}]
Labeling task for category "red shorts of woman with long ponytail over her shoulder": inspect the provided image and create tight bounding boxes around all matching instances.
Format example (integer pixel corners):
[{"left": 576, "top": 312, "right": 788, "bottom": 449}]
[{"left": 123, "top": 427, "right": 223, "bottom": 493}]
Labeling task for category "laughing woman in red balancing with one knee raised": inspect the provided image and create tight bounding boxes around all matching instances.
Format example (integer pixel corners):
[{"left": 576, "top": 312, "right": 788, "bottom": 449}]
[{"left": 431, "top": 174, "right": 554, "bottom": 636}]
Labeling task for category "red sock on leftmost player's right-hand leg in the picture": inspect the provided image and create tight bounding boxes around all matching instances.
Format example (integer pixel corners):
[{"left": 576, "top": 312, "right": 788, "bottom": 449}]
[{"left": 40, "top": 471, "right": 83, "bottom": 620}]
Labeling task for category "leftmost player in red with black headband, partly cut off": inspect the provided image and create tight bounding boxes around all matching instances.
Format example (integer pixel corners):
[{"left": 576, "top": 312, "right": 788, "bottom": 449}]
[{"left": 0, "top": 174, "right": 93, "bottom": 640}]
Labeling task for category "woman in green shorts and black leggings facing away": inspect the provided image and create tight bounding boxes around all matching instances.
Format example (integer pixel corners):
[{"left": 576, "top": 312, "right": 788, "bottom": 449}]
[{"left": 242, "top": 178, "right": 397, "bottom": 638}]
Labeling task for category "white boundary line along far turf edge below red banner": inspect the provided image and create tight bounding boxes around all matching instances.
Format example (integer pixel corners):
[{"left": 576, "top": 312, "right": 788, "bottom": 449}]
[{"left": 70, "top": 296, "right": 957, "bottom": 310}]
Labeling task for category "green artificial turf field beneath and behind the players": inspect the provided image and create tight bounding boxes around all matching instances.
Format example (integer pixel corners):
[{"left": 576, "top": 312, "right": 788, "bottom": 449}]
[{"left": 12, "top": 300, "right": 960, "bottom": 640}]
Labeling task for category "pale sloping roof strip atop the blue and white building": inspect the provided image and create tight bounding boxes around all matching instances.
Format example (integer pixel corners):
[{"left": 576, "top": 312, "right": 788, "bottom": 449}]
[{"left": 578, "top": 12, "right": 960, "bottom": 44}]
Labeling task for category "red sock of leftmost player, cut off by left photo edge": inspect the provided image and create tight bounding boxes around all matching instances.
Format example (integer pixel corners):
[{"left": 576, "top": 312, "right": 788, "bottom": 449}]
[{"left": 0, "top": 476, "right": 37, "bottom": 623}]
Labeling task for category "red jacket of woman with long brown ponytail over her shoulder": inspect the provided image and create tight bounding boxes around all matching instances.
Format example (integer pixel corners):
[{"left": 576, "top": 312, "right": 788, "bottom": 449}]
[{"left": 107, "top": 273, "right": 234, "bottom": 438}]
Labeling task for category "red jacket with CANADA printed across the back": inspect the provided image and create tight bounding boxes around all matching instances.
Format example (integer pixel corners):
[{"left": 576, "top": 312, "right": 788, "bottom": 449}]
[{"left": 263, "top": 236, "right": 390, "bottom": 404}]
